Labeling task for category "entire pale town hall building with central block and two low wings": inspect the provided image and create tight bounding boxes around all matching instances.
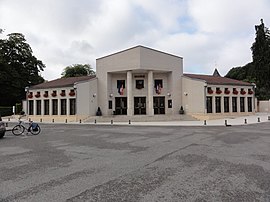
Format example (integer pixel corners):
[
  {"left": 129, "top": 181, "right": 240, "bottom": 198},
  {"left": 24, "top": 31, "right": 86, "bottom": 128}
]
[{"left": 24, "top": 46, "right": 255, "bottom": 121}]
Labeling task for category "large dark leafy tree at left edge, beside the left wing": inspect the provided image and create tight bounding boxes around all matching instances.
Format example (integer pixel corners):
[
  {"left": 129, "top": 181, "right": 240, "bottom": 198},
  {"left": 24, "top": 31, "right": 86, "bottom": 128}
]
[{"left": 0, "top": 33, "right": 45, "bottom": 106}]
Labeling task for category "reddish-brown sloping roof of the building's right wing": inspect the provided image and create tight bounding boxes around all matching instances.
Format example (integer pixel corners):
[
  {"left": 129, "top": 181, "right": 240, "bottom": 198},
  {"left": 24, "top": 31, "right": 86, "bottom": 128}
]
[{"left": 184, "top": 74, "right": 252, "bottom": 86}]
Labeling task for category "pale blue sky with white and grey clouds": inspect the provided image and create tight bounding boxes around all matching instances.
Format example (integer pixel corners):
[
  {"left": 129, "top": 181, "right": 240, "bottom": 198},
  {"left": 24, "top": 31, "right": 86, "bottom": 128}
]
[{"left": 0, "top": 0, "right": 270, "bottom": 80}]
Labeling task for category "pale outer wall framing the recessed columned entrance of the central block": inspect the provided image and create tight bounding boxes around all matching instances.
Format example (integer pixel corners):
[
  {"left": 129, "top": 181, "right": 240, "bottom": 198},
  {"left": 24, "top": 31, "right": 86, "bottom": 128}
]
[{"left": 97, "top": 46, "right": 183, "bottom": 115}]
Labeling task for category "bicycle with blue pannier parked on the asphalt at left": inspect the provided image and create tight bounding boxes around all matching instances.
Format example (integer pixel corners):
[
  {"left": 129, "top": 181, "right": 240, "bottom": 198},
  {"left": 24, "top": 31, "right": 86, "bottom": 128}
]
[{"left": 12, "top": 117, "right": 41, "bottom": 136}]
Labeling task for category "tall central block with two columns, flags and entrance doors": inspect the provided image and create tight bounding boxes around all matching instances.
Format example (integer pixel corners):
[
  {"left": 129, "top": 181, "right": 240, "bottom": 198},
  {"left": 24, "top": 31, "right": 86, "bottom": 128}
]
[{"left": 97, "top": 46, "right": 183, "bottom": 116}]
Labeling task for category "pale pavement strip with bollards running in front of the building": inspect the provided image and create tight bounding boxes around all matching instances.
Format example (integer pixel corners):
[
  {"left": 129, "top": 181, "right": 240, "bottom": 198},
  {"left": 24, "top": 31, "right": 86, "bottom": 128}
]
[{"left": 2, "top": 113, "right": 270, "bottom": 128}]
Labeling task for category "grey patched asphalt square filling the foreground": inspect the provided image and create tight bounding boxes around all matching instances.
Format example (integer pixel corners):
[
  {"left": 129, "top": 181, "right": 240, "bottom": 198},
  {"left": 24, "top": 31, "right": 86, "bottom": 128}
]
[{"left": 0, "top": 122, "right": 270, "bottom": 202}]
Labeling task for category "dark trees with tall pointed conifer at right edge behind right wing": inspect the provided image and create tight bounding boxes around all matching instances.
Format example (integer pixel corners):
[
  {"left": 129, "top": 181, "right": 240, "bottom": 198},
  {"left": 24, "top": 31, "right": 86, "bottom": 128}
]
[{"left": 225, "top": 20, "right": 270, "bottom": 100}]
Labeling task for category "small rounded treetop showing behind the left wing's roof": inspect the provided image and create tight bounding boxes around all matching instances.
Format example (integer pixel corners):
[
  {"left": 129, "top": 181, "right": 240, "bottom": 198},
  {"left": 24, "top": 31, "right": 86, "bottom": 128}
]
[{"left": 61, "top": 64, "right": 96, "bottom": 78}]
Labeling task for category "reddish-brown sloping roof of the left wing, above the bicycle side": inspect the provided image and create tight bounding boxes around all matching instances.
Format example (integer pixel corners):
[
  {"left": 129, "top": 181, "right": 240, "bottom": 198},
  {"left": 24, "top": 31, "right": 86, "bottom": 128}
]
[{"left": 30, "top": 76, "right": 96, "bottom": 89}]
